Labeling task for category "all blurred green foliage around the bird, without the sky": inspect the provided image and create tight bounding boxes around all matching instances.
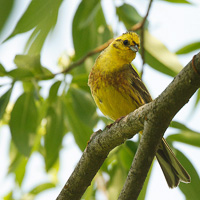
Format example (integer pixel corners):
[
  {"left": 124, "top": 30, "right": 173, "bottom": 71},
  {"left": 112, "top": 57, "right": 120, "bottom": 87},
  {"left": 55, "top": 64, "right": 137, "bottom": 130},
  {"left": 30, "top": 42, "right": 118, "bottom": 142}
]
[{"left": 0, "top": 0, "right": 200, "bottom": 199}]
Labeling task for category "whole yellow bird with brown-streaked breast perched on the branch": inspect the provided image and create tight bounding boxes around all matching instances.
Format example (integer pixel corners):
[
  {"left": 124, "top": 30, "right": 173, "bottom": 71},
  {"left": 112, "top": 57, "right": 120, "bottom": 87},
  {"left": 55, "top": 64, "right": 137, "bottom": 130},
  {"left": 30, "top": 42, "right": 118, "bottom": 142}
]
[{"left": 88, "top": 32, "right": 190, "bottom": 188}]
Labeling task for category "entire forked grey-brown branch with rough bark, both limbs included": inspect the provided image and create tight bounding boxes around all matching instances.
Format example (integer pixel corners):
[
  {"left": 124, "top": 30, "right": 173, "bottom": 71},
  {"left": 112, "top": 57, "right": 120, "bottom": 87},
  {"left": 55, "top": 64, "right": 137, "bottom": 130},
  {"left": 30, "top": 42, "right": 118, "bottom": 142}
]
[{"left": 57, "top": 53, "right": 200, "bottom": 200}]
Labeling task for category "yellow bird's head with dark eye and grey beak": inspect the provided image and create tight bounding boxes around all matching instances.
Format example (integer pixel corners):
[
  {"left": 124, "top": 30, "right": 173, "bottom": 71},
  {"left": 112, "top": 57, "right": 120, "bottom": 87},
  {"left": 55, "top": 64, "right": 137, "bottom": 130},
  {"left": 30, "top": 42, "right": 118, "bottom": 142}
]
[{"left": 110, "top": 32, "right": 140, "bottom": 63}]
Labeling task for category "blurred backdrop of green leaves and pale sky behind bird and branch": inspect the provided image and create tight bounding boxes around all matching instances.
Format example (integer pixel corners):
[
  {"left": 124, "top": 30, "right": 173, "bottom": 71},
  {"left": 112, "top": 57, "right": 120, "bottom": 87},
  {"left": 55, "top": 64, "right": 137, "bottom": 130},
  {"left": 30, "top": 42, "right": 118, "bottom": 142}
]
[{"left": 0, "top": 0, "right": 200, "bottom": 200}]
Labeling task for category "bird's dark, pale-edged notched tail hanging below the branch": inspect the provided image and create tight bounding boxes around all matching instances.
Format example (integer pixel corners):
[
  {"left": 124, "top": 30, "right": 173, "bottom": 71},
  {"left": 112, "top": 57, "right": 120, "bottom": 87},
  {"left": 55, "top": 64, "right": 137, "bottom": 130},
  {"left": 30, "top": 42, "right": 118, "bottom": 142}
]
[{"left": 156, "top": 138, "right": 190, "bottom": 188}]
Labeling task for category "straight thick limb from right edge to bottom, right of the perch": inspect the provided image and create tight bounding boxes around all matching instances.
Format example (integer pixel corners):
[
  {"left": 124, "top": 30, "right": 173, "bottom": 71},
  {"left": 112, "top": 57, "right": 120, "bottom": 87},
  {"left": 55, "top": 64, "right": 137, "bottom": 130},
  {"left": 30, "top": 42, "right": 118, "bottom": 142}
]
[{"left": 119, "top": 53, "right": 200, "bottom": 200}]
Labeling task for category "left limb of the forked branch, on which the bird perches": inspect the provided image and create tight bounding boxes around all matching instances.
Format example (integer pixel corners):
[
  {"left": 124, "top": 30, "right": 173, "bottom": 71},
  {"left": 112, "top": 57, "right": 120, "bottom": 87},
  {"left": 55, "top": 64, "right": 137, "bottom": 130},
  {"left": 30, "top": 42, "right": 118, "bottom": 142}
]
[{"left": 57, "top": 105, "right": 148, "bottom": 200}]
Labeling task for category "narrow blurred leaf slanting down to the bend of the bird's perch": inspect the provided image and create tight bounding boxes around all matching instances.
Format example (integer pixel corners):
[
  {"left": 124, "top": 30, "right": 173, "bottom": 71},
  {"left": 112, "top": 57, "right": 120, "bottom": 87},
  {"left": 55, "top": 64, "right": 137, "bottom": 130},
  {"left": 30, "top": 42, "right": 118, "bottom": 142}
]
[{"left": 63, "top": 91, "right": 93, "bottom": 151}]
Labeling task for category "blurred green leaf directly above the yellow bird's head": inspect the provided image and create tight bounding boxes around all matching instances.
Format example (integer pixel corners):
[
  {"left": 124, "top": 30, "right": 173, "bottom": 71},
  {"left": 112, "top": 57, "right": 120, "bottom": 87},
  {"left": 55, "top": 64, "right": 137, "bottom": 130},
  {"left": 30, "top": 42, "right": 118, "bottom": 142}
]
[{"left": 116, "top": 3, "right": 143, "bottom": 30}]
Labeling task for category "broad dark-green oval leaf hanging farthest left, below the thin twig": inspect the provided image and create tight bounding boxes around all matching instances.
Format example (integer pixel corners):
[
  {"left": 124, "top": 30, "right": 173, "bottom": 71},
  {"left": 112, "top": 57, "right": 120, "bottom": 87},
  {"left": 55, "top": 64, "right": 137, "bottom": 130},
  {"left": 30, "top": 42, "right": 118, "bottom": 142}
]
[{"left": 10, "top": 92, "right": 38, "bottom": 156}]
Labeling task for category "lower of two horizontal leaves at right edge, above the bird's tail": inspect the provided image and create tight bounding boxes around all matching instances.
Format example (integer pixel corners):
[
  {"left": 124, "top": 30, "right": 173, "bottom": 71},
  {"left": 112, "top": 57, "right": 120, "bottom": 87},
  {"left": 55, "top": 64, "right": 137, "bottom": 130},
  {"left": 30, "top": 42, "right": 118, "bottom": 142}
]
[{"left": 167, "top": 131, "right": 200, "bottom": 147}]
